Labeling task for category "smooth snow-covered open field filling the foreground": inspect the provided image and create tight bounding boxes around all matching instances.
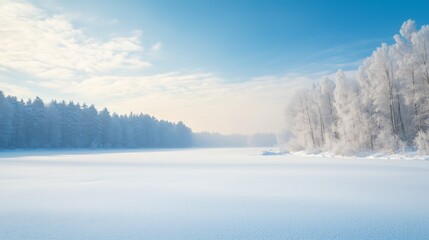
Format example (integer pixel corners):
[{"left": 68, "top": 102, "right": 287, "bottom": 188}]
[{"left": 0, "top": 149, "right": 429, "bottom": 240}]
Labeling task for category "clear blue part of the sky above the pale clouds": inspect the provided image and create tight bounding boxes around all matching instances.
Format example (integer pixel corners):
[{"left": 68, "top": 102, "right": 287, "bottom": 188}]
[{"left": 52, "top": 0, "right": 429, "bottom": 80}]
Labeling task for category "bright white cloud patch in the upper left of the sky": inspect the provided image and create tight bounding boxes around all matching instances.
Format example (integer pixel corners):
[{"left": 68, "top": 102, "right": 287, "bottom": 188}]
[{"left": 0, "top": 1, "right": 150, "bottom": 79}]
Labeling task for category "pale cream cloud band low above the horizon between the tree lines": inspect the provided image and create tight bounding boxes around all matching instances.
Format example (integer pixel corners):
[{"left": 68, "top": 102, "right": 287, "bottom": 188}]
[{"left": 59, "top": 72, "right": 321, "bottom": 133}]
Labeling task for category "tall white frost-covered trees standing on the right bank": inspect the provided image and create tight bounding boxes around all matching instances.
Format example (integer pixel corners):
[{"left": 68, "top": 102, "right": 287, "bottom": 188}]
[{"left": 287, "top": 20, "right": 429, "bottom": 154}]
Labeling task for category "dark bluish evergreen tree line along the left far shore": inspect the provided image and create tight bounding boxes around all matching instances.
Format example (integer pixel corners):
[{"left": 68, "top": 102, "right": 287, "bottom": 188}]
[{"left": 0, "top": 91, "right": 192, "bottom": 149}]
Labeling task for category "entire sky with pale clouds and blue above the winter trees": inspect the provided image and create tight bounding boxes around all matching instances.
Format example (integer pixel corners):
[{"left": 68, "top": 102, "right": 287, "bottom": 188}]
[{"left": 0, "top": 0, "right": 429, "bottom": 134}]
